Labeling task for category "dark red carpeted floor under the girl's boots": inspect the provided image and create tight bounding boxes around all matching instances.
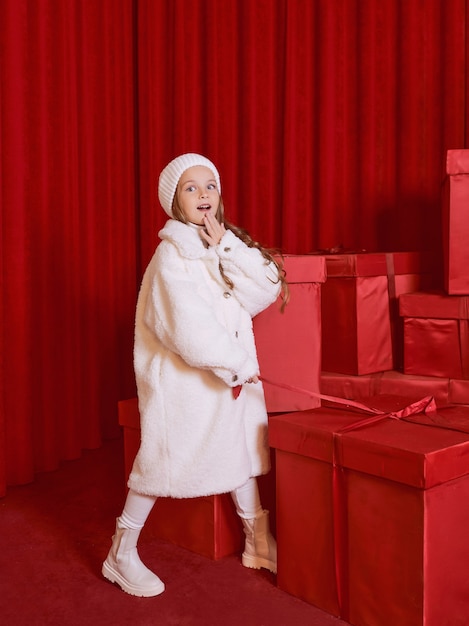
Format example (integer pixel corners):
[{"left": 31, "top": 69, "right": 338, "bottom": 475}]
[{"left": 0, "top": 441, "right": 345, "bottom": 626}]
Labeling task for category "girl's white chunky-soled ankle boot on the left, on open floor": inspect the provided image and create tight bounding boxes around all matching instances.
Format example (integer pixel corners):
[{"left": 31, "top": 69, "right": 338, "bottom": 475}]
[{"left": 102, "top": 519, "right": 164, "bottom": 598}]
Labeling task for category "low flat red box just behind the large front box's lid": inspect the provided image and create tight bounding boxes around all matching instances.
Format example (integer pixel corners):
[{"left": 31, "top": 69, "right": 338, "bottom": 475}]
[{"left": 321, "top": 370, "right": 450, "bottom": 406}]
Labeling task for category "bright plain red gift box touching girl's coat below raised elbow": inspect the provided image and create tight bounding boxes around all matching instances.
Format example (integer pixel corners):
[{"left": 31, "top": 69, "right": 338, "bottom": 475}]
[{"left": 253, "top": 255, "right": 326, "bottom": 413}]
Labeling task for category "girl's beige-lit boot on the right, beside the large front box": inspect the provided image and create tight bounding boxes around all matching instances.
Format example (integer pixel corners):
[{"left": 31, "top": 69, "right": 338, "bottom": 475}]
[{"left": 242, "top": 511, "right": 277, "bottom": 574}]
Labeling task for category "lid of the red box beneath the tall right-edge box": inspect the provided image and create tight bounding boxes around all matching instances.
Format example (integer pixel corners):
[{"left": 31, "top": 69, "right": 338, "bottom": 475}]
[{"left": 399, "top": 291, "right": 469, "bottom": 319}]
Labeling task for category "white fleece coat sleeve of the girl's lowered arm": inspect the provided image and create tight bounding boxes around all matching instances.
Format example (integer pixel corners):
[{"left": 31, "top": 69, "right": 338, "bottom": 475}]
[{"left": 137, "top": 240, "right": 259, "bottom": 387}]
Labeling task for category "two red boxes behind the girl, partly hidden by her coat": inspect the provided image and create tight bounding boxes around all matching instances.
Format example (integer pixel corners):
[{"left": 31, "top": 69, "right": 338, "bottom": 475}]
[{"left": 118, "top": 255, "right": 326, "bottom": 559}]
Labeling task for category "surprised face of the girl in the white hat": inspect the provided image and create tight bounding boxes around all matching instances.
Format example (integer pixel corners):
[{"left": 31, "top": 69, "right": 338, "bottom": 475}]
[{"left": 176, "top": 165, "right": 220, "bottom": 226}]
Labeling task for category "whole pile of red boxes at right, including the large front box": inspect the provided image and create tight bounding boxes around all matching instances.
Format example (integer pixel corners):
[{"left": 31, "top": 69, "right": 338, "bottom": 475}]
[{"left": 270, "top": 150, "right": 469, "bottom": 626}]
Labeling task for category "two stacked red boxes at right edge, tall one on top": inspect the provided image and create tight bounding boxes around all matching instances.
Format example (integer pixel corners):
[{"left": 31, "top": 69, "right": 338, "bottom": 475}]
[{"left": 400, "top": 150, "right": 469, "bottom": 386}]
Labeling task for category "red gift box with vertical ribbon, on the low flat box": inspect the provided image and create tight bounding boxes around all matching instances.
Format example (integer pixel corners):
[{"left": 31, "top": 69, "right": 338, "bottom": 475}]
[{"left": 322, "top": 252, "right": 434, "bottom": 375}]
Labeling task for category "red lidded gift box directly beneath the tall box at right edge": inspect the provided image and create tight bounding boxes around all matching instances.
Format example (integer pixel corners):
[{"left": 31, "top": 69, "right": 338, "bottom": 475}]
[{"left": 399, "top": 292, "right": 469, "bottom": 379}]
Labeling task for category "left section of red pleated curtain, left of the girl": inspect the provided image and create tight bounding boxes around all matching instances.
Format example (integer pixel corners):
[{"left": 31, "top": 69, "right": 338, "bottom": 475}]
[{"left": 0, "top": 0, "right": 136, "bottom": 491}]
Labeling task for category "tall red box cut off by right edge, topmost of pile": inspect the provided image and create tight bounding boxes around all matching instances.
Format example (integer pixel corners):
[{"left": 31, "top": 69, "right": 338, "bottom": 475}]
[{"left": 443, "top": 150, "right": 469, "bottom": 295}]
